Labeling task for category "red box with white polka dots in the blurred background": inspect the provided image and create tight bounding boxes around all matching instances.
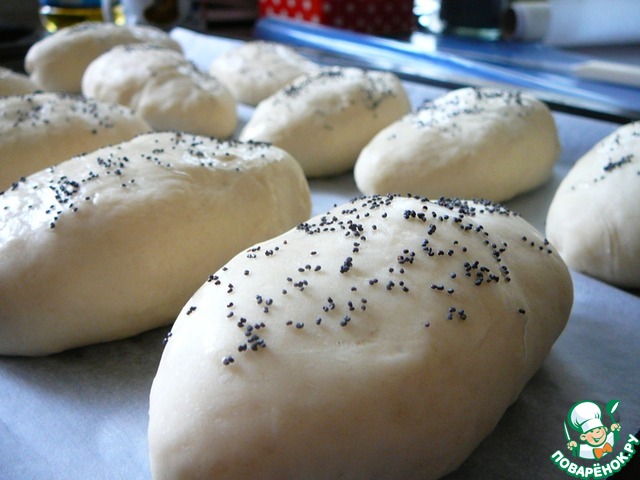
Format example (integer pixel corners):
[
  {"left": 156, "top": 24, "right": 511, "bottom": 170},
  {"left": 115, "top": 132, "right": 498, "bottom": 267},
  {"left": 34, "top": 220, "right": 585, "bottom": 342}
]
[{"left": 258, "top": 0, "right": 415, "bottom": 35}]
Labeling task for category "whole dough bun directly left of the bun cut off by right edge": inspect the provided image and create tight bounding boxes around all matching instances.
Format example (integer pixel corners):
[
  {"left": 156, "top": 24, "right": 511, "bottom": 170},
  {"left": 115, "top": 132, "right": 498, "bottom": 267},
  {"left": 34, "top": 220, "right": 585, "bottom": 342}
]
[{"left": 354, "top": 88, "right": 560, "bottom": 202}]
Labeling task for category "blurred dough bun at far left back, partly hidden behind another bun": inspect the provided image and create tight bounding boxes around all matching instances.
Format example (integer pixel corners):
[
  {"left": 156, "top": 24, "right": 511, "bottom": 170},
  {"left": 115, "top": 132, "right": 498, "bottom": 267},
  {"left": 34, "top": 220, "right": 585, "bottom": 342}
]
[{"left": 25, "top": 22, "right": 182, "bottom": 93}]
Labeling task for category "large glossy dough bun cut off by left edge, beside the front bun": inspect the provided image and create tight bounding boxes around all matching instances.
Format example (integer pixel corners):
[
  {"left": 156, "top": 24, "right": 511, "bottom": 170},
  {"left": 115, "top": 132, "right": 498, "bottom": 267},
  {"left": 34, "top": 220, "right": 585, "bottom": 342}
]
[{"left": 0, "top": 133, "right": 310, "bottom": 355}]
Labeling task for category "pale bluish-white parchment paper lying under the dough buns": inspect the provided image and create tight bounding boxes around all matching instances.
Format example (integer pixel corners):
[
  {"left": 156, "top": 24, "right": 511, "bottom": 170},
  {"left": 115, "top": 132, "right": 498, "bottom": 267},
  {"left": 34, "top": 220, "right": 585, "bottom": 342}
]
[{"left": 0, "top": 27, "right": 640, "bottom": 480}]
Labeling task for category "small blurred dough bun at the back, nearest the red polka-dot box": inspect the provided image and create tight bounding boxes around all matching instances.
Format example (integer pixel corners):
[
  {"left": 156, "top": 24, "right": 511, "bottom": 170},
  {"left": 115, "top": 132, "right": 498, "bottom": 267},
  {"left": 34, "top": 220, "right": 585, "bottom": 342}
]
[{"left": 209, "top": 40, "right": 319, "bottom": 106}]
